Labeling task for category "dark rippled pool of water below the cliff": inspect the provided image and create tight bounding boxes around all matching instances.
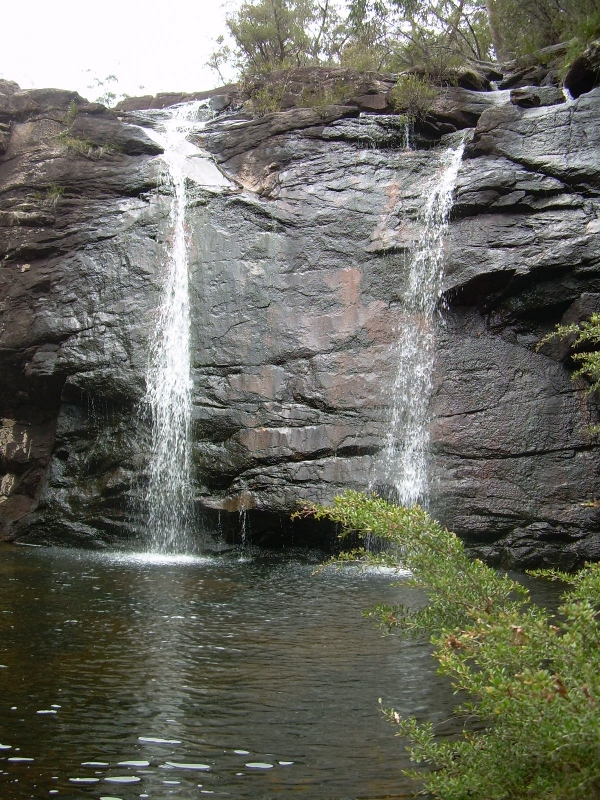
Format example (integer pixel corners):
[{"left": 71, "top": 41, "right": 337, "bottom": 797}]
[{"left": 0, "top": 546, "right": 453, "bottom": 800}]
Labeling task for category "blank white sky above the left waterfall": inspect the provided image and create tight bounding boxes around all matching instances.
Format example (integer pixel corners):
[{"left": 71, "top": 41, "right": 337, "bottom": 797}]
[{"left": 0, "top": 0, "right": 238, "bottom": 100}]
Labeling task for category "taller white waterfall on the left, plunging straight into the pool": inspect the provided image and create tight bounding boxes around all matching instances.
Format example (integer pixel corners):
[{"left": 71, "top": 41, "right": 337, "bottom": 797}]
[{"left": 146, "top": 102, "right": 200, "bottom": 552}]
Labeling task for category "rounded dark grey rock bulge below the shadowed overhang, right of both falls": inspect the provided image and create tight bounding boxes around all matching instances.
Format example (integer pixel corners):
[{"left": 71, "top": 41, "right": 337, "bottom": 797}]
[{"left": 432, "top": 310, "right": 600, "bottom": 569}]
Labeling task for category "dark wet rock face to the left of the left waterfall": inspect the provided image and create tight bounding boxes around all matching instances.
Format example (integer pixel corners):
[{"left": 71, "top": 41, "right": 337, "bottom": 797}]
[{"left": 0, "top": 84, "right": 168, "bottom": 542}]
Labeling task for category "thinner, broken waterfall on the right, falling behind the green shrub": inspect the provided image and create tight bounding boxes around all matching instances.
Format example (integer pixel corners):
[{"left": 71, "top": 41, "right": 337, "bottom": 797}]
[{"left": 381, "top": 143, "right": 464, "bottom": 506}]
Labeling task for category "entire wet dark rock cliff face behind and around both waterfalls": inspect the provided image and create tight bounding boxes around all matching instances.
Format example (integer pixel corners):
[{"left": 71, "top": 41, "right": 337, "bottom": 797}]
[{"left": 0, "top": 73, "right": 600, "bottom": 567}]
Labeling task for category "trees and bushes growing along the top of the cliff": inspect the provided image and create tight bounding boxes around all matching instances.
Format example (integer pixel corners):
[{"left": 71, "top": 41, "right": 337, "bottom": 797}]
[{"left": 209, "top": 0, "right": 600, "bottom": 79}]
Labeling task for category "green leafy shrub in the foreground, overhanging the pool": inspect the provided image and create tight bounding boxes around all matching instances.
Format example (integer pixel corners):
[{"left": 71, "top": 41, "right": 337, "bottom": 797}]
[{"left": 301, "top": 492, "right": 600, "bottom": 800}]
